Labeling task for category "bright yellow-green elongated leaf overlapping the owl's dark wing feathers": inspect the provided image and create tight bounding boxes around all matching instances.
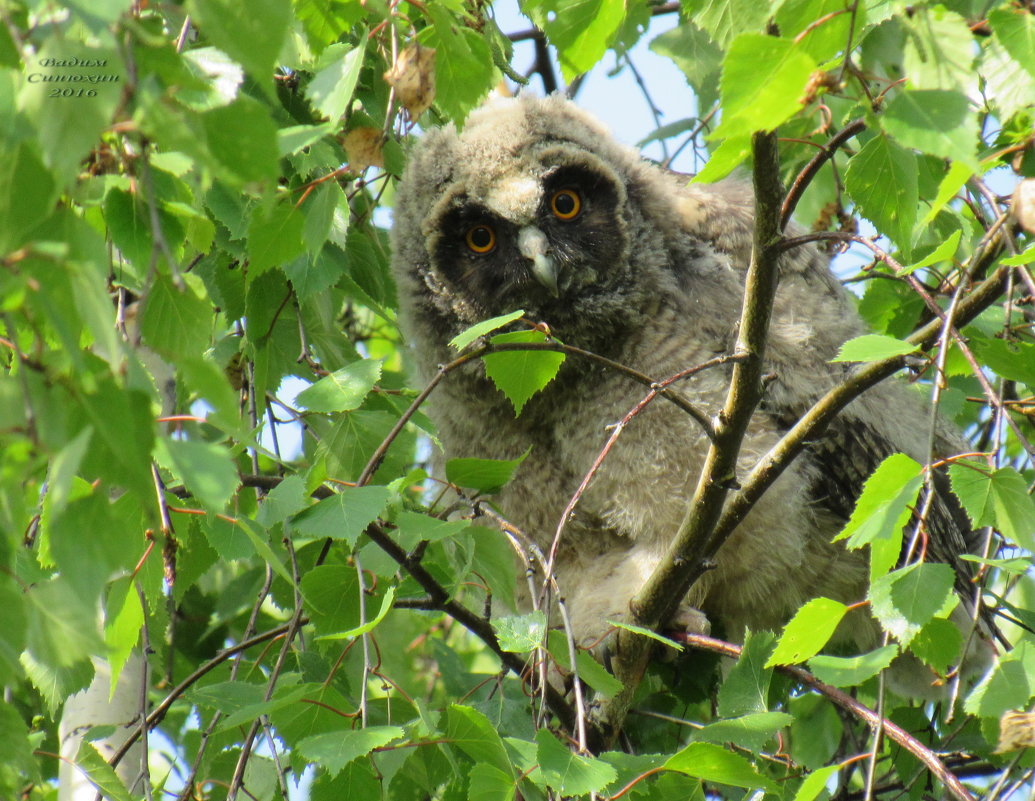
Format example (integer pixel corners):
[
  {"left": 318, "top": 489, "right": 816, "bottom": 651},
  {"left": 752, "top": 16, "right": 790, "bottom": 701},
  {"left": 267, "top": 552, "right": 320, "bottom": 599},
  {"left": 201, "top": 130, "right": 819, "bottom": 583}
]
[{"left": 834, "top": 453, "right": 923, "bottom": 576}]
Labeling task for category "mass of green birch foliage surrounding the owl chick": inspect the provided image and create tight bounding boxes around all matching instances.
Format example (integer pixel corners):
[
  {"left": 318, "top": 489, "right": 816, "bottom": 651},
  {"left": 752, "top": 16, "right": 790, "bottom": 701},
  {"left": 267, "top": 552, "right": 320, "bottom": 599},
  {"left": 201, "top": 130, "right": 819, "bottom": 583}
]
[{"left": 0, "top": 0, "right": 1035, "bottom": 801}]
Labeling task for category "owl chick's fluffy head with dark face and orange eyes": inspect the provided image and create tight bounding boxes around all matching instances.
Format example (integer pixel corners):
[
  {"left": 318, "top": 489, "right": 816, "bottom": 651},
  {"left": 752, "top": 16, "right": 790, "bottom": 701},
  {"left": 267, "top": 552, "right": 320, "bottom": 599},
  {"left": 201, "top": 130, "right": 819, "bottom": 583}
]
[{"left": 392, "top": 96, "right": 662, "bottom": 337}]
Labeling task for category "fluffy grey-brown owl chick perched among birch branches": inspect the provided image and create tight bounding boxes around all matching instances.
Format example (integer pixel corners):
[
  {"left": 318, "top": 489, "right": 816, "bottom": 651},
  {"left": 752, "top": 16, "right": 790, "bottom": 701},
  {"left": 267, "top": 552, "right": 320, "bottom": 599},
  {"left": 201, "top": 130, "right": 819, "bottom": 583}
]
[{"left": 392, "top": 96, "right": 966, "bottom": 658}]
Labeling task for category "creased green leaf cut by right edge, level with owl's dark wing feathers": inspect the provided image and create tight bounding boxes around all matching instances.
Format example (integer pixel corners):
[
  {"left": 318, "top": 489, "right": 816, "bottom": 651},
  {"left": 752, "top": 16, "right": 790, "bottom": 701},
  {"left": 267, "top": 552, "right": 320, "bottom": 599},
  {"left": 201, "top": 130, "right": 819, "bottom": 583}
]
[{"left": 949, "top": 463, "right": 1035, "bottom": 551}]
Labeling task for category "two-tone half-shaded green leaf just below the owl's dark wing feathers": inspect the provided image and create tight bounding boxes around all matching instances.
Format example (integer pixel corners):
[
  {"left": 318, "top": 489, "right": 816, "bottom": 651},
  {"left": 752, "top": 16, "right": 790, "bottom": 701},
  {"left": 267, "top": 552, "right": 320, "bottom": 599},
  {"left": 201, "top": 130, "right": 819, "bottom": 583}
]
[{"left": 869, "top": 562, "right": 956, "bottom": 648}]
